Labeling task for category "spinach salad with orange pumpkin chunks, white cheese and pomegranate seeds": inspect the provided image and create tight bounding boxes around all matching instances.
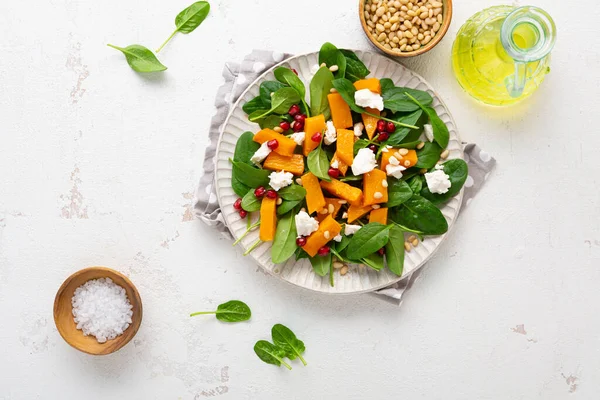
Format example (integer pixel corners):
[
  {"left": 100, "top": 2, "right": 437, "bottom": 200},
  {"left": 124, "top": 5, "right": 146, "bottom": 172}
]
[{"left": 230, "top": 43, "right": 468, "bottom": 286}]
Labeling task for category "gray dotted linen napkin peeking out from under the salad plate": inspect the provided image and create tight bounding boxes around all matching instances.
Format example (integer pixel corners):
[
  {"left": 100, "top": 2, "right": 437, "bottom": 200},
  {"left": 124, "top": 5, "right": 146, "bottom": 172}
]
[{"left": 194, "top": 50, "right": 496, "bottom": 306}]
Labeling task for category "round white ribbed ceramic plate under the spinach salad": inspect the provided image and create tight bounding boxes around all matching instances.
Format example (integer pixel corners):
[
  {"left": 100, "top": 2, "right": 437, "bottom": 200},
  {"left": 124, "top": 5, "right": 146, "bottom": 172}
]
[{"left": 215, "top": 51, "right": 464, "bottom": 294}]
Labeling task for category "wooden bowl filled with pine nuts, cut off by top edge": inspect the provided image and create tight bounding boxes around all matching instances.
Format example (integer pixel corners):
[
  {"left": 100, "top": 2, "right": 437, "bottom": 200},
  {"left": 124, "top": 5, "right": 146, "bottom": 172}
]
[{"left": 358, "top": 0, "right": 452, "bottom": 57}]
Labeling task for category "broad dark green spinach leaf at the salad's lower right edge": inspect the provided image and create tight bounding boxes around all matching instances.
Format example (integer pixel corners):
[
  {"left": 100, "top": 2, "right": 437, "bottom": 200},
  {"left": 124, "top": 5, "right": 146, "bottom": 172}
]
[{"left": 392, "top": 194, "right": 448, "bottom": 235}]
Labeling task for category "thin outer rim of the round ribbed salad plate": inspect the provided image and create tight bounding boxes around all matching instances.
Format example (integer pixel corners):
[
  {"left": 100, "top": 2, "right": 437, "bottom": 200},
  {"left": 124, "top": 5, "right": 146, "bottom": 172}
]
[{"left": 213, "top": 49, "right": 465, "bottom": 296}]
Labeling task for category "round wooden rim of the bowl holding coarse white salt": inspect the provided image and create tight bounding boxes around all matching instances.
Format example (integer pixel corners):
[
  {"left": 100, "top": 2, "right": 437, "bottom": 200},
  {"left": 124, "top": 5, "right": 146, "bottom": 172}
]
[{"left": 53, "top": 266, "right": 144, "bottom": 356}]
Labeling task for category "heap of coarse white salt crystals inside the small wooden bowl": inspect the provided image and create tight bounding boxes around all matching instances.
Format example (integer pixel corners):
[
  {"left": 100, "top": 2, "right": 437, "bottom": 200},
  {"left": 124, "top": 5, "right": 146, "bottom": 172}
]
[{"left": 71, "top": 278, "right": 133, "bottom": 343}]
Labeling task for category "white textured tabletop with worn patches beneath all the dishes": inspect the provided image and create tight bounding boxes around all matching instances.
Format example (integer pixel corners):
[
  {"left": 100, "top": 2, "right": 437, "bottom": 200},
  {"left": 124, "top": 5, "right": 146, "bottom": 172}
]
[{"left": 0, "top": 0, "right": 600, "bottom": 400}]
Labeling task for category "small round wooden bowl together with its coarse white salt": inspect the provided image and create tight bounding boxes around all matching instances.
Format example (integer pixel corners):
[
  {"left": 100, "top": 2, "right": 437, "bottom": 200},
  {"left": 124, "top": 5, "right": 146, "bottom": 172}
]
[{"left": 54, "top": 267, "right": 142, "bottom": 355}]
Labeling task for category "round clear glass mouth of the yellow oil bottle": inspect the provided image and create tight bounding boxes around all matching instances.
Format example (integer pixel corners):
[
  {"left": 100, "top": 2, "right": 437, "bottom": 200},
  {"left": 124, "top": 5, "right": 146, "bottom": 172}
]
[{"left": 500, "top": 6, "right": 556, "bottom": 63}]
